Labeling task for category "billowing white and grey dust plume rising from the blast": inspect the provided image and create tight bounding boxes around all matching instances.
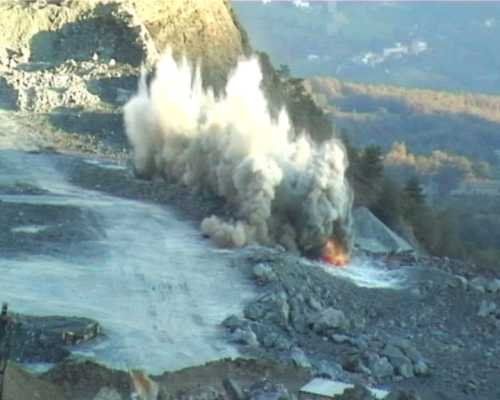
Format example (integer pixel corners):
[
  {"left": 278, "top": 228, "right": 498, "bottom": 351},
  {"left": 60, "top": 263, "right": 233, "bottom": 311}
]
[{"left": 125, "top": 52, "right": 352, "bottom": 253}]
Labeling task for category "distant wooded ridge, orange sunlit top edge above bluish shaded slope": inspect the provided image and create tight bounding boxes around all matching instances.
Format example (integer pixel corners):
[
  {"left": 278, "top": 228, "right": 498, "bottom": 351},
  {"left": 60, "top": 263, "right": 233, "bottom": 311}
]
[{"left": 306, "top": 78, "right": 500, "bottom": 165}]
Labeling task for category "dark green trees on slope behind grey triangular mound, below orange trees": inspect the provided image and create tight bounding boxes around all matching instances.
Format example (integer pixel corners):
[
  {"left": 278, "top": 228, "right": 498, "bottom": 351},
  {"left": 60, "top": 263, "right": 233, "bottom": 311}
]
[{"left": 346, "top": 140, "right": 500, "bottom": 267}]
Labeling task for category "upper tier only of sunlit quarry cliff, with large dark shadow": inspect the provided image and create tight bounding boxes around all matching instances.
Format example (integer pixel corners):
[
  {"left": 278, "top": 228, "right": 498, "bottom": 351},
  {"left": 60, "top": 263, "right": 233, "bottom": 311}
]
[{"left": 0, "top": 0, "right": 247, "bottom": 77}]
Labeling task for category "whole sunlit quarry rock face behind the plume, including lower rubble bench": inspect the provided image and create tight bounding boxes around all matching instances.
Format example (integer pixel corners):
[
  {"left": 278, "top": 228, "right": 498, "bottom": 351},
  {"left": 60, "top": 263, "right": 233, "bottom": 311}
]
[{"left": 0, "top": 0, "right": 249, "bottom": 115}]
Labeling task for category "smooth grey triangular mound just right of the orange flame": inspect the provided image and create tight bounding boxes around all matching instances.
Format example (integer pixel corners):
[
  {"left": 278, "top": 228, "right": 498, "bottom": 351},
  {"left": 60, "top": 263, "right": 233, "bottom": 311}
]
[{"left": 352, "top": 207, "right": 414, "bottom": 254}]
